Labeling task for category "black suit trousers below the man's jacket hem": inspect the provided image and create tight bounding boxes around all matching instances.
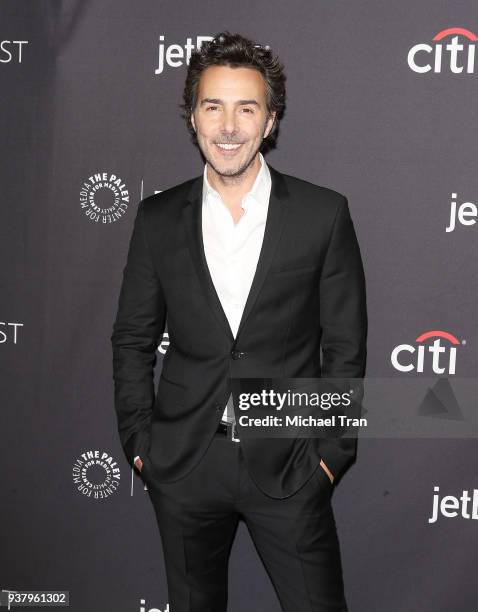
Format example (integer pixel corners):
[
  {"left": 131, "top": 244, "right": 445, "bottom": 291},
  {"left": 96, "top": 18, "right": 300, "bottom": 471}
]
[{"left": 142, "top": 434, "right": 347, "bottom": 612}]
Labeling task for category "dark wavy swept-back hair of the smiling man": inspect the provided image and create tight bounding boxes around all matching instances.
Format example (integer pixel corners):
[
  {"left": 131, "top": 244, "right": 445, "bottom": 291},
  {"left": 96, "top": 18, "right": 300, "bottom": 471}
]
[{"left": 180, "top": 30, "right": 286, "bottom": 151}]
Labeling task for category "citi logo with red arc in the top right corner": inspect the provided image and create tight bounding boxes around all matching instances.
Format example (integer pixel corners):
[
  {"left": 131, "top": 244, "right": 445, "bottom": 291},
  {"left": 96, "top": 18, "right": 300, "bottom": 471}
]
[{"left": 407, "top": 28, "right": 478, "bottom": 74}]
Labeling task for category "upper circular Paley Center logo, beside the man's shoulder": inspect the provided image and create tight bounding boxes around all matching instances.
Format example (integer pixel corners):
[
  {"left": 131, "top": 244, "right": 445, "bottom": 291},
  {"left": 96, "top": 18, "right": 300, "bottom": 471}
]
[{"left": 80, "top": 172, "right": 129, "bottom": 224}]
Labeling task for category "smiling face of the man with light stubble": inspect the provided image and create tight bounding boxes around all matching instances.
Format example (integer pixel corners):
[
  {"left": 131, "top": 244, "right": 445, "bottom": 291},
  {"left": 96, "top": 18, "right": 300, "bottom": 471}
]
[{"left": 191, "top": 66, "right": 275, "bottom": 176}]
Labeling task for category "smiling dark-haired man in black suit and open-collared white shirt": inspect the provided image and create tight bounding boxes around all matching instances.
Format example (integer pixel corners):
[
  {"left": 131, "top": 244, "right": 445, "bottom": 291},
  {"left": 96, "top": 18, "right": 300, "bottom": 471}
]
[{"left": 111, "top": 32, "right": 367, "bottom": 612}]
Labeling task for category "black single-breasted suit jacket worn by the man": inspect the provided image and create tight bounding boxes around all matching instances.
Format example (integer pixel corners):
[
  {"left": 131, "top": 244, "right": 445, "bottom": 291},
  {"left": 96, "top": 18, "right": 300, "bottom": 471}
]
[{"left": 111, "top": 165, "right": 367, "bottom": 498}]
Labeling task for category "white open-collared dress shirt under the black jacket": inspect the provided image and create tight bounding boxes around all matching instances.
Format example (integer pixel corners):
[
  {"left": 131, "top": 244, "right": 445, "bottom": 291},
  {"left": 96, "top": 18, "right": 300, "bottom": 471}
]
[{"left": 134, "top": 153, "right": 271, "bottom": 461}]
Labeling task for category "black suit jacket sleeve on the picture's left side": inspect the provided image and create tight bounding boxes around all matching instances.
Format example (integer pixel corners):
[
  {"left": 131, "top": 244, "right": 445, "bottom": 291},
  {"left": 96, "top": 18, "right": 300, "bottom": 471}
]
[{"left": 111, "top": 201, "right": 166, "bottom": 464}]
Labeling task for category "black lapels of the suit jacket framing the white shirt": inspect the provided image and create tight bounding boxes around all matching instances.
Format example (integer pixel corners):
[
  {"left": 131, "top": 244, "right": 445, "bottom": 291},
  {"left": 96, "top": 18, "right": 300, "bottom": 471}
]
[{"left": 183, "top": 164, "right": 288, "bottom": 341}]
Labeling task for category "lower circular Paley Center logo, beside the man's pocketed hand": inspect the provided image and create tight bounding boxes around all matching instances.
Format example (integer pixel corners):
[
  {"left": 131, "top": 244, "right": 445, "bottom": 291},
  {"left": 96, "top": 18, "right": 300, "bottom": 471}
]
[{"left": 72, "top": 450, "right": 121, "bottom": 499}]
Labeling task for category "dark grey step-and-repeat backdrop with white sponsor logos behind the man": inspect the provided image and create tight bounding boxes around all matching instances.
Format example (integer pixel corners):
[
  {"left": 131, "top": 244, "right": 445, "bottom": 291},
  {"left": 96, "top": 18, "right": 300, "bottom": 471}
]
[{"left": 0, "top": 0, "right": 478, "bottom": 612}]
